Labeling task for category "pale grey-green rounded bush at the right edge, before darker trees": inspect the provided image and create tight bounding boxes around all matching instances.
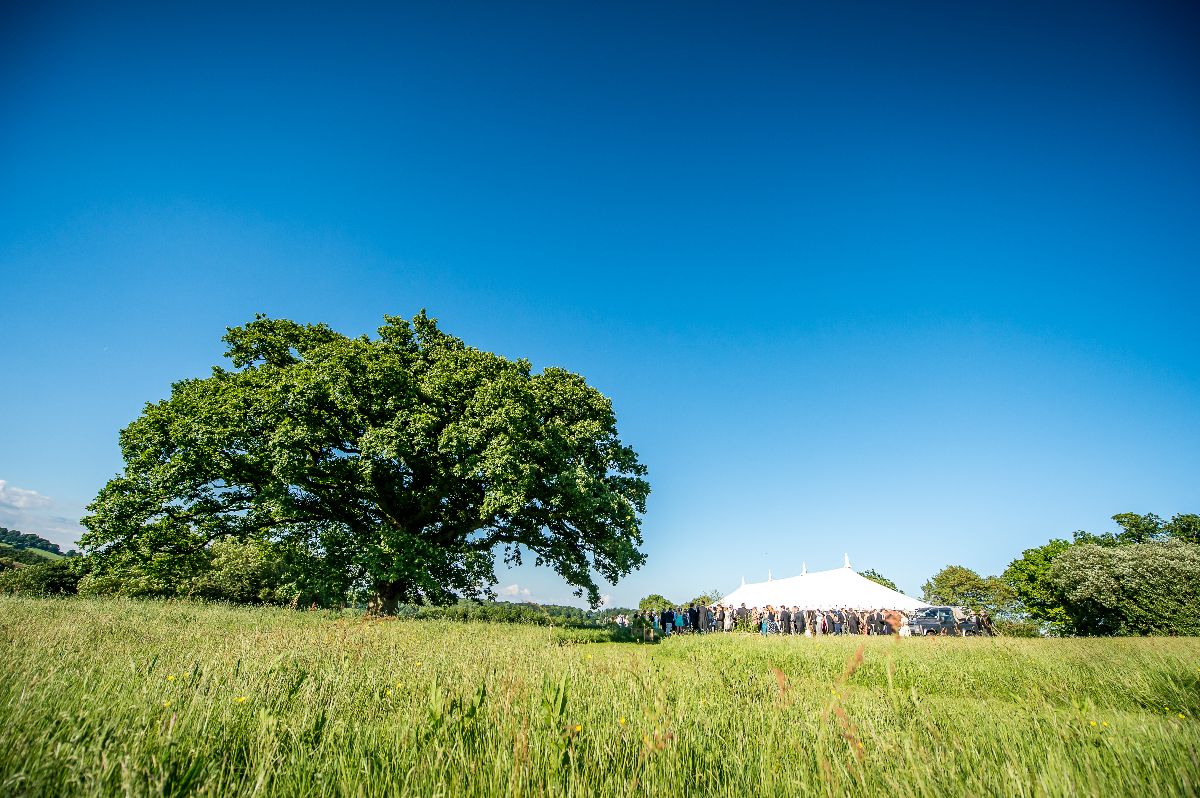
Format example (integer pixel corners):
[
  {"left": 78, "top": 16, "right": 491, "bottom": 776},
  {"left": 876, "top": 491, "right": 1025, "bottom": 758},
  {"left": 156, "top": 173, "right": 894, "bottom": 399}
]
[{"left": 1050, "top": 540, "right": 1200, "bottom": 635}]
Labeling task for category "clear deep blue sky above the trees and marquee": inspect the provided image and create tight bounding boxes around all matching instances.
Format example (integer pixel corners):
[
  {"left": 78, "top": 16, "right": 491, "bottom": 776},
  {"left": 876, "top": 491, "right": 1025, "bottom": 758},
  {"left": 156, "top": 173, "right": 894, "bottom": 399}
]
[{"left": 0, "top": 1, "right": 1200, "bottom": 604}]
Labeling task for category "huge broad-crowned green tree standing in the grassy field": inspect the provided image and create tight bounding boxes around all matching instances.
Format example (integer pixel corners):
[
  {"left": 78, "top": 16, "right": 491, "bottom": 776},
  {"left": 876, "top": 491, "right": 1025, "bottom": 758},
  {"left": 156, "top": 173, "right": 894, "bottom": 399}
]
[{"left": 82, "top": 312, "right": 649, "bottom": 612}]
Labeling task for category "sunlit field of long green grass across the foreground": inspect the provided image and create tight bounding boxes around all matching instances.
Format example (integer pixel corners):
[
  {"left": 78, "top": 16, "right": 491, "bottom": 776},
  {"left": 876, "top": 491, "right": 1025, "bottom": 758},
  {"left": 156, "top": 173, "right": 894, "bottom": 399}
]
[{"left": 0, "top": 598, "right": 1200, "bottom": 798}]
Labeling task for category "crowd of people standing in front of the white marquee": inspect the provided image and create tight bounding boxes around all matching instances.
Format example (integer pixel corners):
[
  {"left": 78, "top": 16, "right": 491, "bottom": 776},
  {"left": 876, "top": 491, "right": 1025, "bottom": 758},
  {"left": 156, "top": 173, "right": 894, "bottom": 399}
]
[{"left": 617, "top": 604, "right": 995, "bottom": 637}]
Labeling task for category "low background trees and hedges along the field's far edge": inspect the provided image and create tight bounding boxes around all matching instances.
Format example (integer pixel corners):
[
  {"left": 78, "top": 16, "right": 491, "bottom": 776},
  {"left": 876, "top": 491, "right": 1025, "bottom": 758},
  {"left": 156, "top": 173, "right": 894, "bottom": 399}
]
[{"left": 0, "top": 512, "right": 1200, "bottom": 636}]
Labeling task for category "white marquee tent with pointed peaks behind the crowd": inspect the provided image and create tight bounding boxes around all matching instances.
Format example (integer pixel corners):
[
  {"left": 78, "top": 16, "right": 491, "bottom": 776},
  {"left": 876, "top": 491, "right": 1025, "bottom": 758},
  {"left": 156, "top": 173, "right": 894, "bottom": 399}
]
[{"left": 721, "top": 557, "right": 929, "bottom": 612}]
